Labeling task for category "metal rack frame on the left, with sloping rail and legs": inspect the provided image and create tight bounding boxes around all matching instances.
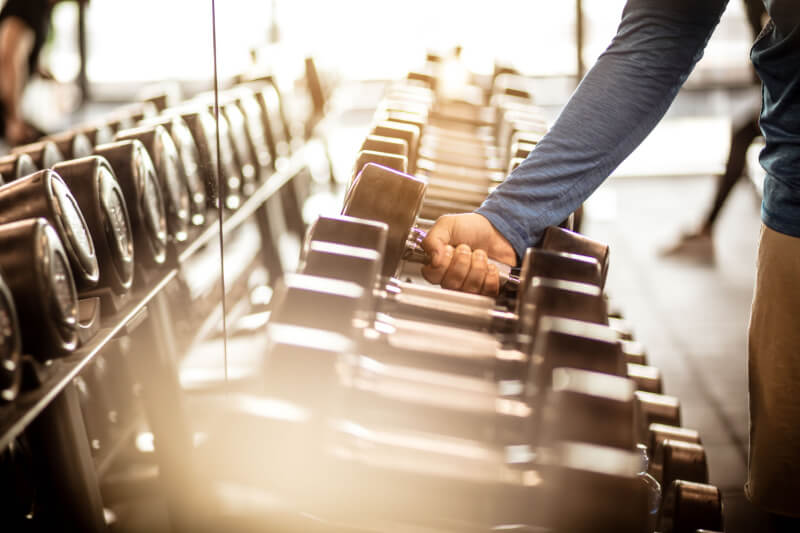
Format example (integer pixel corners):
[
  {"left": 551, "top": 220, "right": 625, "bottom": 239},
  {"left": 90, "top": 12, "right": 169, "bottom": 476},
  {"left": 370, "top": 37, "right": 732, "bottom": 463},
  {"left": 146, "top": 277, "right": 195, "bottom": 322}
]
[{"left": 0, "top": 69, "right": 324, "bottom": 531}]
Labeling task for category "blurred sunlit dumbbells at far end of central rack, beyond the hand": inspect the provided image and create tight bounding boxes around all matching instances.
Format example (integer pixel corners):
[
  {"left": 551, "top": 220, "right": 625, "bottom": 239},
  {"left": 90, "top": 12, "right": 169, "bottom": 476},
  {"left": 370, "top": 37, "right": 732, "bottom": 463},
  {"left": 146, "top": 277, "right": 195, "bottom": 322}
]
[{"left": 346, "top": 69, "right": 546, "bottom": 222}]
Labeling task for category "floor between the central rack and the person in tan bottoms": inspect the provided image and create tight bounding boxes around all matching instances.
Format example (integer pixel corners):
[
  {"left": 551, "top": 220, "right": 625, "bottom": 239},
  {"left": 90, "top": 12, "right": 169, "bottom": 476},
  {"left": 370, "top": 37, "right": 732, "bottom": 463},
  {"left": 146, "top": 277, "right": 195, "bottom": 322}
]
[{"left": 584, "top": 170, "right": 766, "bottom": 533}]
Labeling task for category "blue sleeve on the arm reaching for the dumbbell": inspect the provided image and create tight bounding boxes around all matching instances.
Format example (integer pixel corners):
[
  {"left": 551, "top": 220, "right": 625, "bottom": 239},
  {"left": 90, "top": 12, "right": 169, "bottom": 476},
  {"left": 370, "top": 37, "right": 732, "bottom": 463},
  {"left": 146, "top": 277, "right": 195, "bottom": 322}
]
[{"left": 476, "top": 0, "right": 727, "bottom": 257}]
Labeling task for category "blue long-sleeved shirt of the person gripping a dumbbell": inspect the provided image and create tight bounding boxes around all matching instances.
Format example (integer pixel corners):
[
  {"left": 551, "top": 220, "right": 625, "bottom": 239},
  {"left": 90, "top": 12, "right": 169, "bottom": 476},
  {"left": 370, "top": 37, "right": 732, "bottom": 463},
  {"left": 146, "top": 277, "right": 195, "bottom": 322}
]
[{"left": 477, "top": 0, "right": 800, "bottom": 257}]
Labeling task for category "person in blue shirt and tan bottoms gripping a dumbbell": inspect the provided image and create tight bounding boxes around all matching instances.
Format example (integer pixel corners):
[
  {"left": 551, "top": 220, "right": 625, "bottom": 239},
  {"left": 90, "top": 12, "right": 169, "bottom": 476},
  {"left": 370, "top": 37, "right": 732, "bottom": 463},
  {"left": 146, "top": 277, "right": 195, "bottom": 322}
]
[{"left": 422, "top": 0, "right": 800, "bottom": 531}]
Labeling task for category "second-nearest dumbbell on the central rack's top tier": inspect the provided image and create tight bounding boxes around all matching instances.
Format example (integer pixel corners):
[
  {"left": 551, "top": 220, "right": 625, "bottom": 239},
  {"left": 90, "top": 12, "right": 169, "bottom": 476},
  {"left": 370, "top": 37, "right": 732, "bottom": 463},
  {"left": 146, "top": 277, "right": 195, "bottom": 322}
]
[{"left": 265, "top": 316, "right": 648, "bottom": 462}]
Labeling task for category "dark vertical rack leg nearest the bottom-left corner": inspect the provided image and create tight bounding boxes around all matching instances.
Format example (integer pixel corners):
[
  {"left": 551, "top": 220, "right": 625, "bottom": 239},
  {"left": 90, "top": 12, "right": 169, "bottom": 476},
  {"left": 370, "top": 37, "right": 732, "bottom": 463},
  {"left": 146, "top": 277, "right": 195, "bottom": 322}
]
[{"left": 27, "top": 384, "right": 106, "bottom": 533}]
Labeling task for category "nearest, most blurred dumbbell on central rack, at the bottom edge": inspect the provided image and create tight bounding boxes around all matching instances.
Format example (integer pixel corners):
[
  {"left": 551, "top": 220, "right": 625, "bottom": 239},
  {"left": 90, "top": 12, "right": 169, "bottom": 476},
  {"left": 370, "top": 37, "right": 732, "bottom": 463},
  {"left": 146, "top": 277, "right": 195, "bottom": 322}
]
[{"left": 214, "top": 360, "right": 652, "bottom": 532}]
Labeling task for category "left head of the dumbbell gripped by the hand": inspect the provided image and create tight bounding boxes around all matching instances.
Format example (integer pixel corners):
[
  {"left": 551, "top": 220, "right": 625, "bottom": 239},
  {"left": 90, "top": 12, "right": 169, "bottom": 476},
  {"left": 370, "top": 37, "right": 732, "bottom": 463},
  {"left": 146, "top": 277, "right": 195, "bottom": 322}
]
[{"left": 342, "top": 163, "right": 426, "bottom": 276}]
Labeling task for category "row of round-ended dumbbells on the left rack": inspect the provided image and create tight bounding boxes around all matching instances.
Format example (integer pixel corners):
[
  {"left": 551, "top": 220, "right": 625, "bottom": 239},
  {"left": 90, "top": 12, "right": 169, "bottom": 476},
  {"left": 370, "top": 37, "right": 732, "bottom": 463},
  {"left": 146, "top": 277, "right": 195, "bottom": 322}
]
[{"left": 0, "top": 72, "right": 302, "bottom": 401}]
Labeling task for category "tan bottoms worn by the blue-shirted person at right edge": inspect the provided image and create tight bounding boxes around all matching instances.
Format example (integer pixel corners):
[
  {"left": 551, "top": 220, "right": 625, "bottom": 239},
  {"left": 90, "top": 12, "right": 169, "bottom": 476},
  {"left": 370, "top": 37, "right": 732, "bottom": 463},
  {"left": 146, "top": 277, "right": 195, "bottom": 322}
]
[{"left": 745, "top": 226, "right": 800, "bottom": 517}]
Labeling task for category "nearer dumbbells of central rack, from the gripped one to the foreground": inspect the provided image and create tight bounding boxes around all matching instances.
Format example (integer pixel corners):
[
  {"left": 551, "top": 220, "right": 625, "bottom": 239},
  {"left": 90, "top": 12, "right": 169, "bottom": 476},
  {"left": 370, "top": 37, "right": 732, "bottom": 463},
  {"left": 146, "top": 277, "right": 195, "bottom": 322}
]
[{"left": 244, "top": 64, "right": 722, "bottom": 531}]
